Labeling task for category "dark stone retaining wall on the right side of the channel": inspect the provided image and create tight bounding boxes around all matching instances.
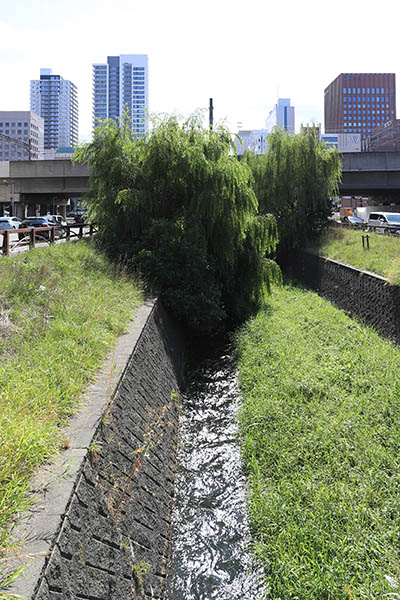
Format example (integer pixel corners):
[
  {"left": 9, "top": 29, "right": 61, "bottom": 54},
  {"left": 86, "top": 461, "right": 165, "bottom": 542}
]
[{"left": 288, "top": 252, "right": 400, "bottom": 343}]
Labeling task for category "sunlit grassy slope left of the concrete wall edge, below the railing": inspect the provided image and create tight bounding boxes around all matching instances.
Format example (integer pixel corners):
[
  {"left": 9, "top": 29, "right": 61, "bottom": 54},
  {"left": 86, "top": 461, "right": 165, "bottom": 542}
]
[{"left": 0, "top": 241, "right": 142, "bottom": 560}]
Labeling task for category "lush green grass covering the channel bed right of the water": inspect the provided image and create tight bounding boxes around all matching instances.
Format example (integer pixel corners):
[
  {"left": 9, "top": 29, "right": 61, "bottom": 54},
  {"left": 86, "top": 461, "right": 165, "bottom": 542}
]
[{"left": 238, "top": 286, "right": 400, "bottom": 600}]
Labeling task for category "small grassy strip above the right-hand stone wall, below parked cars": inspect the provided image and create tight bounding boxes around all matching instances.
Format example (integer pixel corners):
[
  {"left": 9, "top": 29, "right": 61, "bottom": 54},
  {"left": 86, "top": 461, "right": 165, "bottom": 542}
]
[{"left": 317, "top": 227, "right": 400, "bottom": 285}]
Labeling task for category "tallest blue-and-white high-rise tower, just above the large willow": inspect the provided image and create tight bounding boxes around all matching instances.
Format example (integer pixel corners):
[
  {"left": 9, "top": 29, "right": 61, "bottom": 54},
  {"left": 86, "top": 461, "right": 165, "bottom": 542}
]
[{"left": 93, "top": 54, "right": 148, "bottom": 136}]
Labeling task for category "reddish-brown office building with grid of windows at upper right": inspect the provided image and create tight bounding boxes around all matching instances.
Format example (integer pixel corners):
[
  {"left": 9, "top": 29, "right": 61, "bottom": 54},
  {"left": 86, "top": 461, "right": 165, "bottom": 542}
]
[{"left": 324, "top": 73, "right": 396, "bottom": 140}]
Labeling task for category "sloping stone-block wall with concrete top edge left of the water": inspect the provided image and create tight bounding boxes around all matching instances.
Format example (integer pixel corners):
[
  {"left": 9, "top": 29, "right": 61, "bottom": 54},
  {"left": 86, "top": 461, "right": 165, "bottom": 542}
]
[{"left": 10, "top": 304, "right": 183, "bottom": 600}]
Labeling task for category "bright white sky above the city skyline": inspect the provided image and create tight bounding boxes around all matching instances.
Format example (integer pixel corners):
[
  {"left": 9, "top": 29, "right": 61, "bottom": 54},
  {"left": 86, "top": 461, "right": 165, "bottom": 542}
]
[{"left": 0, "top": 0, "right": 400, "bottom": 141}]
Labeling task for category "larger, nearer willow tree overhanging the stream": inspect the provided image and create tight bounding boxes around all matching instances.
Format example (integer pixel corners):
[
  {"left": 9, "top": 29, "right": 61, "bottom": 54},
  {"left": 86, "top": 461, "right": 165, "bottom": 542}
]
[{"left": 76, "top": 116, "right": 280, "bottom": 334}]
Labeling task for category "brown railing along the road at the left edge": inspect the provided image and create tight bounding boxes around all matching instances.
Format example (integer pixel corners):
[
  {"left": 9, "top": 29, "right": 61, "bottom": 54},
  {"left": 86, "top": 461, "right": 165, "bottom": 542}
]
[{"left": 0, "top": 223, "right": 98, "bottom": 256}]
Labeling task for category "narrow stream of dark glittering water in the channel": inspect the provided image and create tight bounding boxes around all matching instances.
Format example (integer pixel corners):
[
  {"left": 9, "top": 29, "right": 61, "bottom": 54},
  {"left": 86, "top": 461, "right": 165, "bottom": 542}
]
[{"left": 165, "top": 353, "right": 266, "bottom": 600}]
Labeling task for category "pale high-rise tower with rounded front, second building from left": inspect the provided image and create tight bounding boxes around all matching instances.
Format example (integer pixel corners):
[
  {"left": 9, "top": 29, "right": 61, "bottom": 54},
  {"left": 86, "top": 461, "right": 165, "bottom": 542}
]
[{"left": 31, "top": 69, "right": 78, "bottom": 150}]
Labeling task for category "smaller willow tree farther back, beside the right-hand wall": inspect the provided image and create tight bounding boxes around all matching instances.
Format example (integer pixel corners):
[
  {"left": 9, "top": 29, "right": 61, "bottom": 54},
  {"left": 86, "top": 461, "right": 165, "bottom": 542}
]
[{"left": 243, "top": 129, "right": 341, "bottom": 256}]
